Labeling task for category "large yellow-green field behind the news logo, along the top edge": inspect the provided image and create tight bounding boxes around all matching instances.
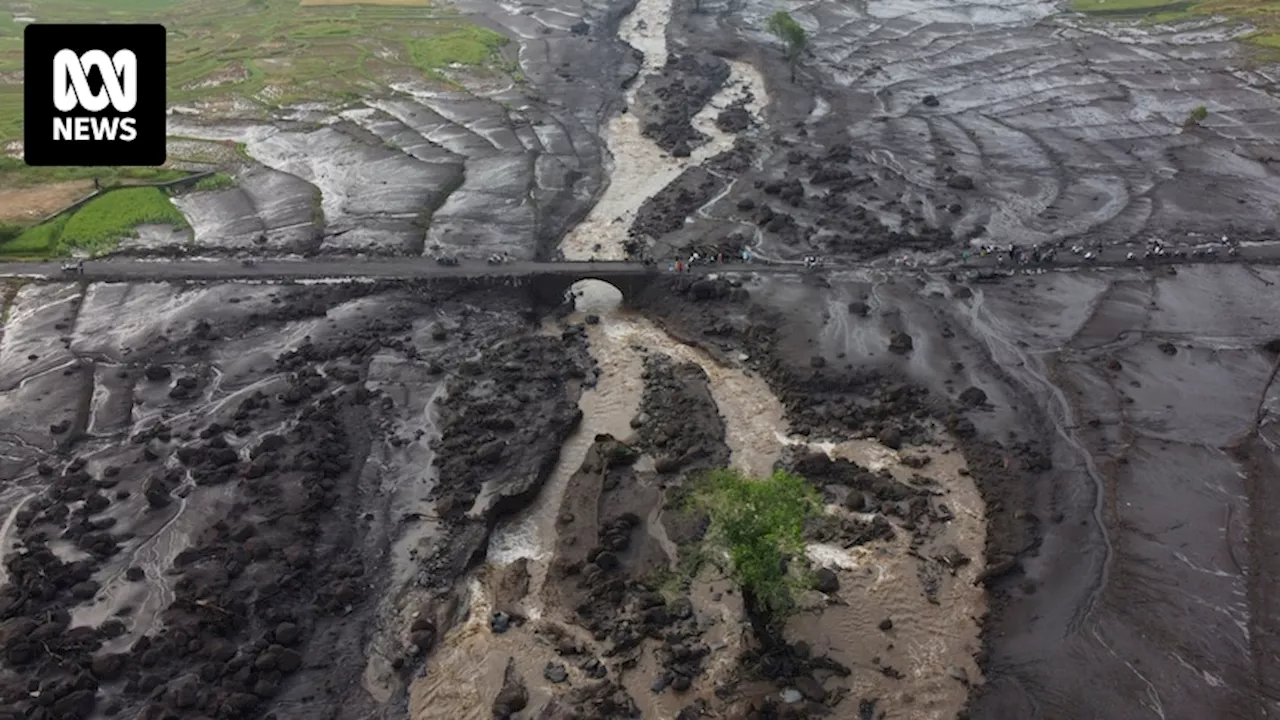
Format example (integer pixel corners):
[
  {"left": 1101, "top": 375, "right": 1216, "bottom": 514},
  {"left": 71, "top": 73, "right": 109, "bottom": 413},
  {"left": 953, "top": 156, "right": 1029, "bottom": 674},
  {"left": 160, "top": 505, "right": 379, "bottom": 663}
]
[{"left": 0, "top": 0, "right": 507, "bottom": 146}]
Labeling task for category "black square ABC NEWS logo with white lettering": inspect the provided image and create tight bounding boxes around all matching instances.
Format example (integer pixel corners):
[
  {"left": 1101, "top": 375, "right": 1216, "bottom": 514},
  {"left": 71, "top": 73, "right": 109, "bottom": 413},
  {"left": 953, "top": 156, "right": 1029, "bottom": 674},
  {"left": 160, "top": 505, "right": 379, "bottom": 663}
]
[{"left": 23, "top": 23, "right": 166, "bottom": 167}]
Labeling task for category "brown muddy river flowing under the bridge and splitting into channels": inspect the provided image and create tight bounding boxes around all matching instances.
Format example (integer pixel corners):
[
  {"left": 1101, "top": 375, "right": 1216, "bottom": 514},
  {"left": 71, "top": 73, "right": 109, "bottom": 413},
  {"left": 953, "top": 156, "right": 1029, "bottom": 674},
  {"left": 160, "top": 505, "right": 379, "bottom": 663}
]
[{"left": 411, "top": 0, "right": 986, "bottom": 720}]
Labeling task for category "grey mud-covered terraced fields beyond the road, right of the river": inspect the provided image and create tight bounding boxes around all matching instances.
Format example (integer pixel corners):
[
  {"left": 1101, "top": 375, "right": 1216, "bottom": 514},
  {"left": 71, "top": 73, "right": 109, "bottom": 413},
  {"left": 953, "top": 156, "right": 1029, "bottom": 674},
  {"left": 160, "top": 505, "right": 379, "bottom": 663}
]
[{"left": 640, "top": 1, "right": 1280, "bottom": 265}]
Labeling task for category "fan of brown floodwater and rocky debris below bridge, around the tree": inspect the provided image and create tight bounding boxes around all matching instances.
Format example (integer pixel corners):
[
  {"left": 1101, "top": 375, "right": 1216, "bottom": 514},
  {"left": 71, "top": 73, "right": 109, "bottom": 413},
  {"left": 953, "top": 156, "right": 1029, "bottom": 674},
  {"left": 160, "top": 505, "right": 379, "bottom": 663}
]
[{"left": 411, "top": 275, "right": 984, "bottom": 719}]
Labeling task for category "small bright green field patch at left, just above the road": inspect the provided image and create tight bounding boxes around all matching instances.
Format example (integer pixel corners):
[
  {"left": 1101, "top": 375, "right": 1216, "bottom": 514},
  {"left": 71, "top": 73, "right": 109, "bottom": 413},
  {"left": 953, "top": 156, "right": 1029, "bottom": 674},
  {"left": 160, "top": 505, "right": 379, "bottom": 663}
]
[{"left": 0, "top": 185, "right": 188, "bottom": 259}]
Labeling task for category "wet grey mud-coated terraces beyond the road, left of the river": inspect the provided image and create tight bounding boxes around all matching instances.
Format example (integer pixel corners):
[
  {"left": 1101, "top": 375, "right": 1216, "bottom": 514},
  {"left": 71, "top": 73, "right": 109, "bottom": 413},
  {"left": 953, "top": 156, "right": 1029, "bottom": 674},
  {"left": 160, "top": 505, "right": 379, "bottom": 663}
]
[{"left": 161, "top": 0, "right": 655, "bottom": 259}]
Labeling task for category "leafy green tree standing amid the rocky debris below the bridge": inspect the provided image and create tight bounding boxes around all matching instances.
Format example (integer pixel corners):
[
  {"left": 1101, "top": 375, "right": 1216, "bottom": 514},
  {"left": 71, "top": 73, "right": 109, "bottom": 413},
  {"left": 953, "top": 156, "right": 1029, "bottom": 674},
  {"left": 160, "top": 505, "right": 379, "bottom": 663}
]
[{"left": 691, "top": 469, "right": 820, "bottom": 644}]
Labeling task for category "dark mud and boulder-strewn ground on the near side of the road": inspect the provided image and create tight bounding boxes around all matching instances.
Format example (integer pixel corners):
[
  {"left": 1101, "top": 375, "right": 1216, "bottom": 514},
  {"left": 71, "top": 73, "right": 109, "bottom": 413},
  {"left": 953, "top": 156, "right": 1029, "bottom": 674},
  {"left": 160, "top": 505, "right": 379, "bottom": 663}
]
[{"left": 0, "top": 265, "right": 1280, "bottom": 717}]
